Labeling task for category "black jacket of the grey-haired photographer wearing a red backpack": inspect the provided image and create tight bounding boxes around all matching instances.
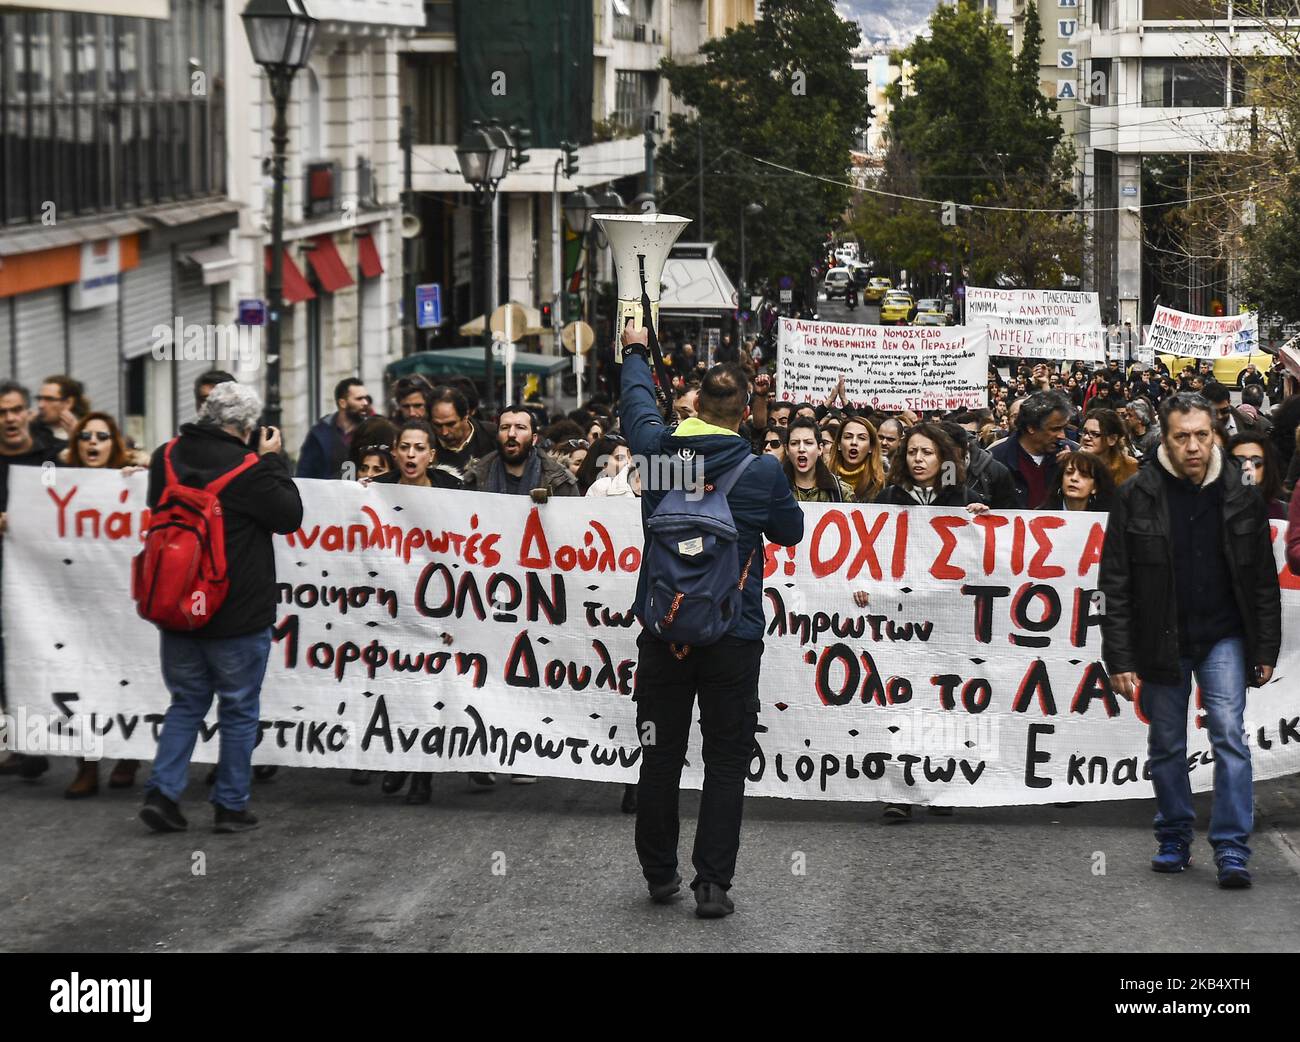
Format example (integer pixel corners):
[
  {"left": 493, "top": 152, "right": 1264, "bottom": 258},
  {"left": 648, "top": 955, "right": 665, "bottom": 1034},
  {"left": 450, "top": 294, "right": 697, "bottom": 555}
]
[{"left": 148, "top": 424, "right": 303, "bottom": 639}]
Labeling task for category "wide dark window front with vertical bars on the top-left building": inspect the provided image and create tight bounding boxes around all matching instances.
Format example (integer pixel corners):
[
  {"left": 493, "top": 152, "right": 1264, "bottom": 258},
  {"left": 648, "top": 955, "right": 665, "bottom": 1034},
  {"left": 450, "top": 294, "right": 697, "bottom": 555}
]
[{"left": 0, "top": 0, "right": 225, "bottom": 225}]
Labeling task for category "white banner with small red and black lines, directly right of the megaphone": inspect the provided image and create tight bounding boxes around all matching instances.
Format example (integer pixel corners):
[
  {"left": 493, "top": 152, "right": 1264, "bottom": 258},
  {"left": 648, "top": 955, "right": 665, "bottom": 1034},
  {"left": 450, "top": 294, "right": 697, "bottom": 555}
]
[{"left": 776, "top": 318, "right": 988, "bottom": 412}]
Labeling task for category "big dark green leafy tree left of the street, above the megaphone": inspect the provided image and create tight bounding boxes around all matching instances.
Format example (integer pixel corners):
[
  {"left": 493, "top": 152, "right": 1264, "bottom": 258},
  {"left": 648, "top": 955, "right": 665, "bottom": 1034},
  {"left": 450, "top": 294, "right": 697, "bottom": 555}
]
[{"left": 658, "top": 0, "right": 867, "bottom": 286}]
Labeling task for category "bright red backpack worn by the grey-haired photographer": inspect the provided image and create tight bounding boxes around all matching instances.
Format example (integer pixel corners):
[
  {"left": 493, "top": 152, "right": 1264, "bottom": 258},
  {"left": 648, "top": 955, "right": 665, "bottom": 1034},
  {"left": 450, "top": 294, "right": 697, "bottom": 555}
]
[{"left": 131, "top": 438, "right": 257, "bottom": 633}]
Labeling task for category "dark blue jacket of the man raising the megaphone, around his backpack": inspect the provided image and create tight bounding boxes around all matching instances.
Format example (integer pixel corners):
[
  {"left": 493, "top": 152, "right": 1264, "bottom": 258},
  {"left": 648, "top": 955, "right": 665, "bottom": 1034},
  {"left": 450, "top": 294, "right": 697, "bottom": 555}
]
[{"left": 619, "top": 355, "right": 803, "bottom": 641}]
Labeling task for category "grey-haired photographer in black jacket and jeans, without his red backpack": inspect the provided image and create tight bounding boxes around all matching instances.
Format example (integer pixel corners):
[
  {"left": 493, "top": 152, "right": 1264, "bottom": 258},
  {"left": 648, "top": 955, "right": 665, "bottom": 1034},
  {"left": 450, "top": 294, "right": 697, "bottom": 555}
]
[{"left": 140, "top": 383, "right": 303, "bottom": 832}]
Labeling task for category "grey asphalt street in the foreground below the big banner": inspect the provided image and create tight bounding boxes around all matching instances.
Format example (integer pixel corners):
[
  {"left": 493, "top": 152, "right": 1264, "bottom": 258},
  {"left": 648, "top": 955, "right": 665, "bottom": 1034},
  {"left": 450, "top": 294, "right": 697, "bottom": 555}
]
[{"left": 0, "top": 761, "right": 1300, "bottom": 952}]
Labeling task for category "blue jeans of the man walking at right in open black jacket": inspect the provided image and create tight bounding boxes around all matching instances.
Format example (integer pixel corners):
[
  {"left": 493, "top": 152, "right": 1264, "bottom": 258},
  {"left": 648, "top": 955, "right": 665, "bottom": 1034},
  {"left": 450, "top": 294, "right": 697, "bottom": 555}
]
[{"left": 1141, "top": 637, "right": 1255, "bottom": 858}]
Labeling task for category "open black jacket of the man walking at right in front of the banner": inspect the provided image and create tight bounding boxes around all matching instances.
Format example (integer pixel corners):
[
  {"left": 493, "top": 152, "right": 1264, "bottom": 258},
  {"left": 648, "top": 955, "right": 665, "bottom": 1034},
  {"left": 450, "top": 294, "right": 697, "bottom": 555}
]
[{"left": 1099, "top": 444, "right": 1282, "bottom": 686}]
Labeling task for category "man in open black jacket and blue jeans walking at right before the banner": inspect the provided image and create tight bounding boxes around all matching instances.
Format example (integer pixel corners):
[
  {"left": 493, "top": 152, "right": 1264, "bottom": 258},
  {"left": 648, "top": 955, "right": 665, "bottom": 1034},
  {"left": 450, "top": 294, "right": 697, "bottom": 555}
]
[{"left": 1100, "top": 394, "right": 1282, "bottom": 887}]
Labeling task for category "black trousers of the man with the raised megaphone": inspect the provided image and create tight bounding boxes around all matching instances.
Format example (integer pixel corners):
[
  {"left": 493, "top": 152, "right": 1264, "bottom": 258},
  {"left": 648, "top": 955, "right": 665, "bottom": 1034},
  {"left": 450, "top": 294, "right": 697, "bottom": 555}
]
[{"left": 636, "top": 631, "right": 763, "bottom": 889}]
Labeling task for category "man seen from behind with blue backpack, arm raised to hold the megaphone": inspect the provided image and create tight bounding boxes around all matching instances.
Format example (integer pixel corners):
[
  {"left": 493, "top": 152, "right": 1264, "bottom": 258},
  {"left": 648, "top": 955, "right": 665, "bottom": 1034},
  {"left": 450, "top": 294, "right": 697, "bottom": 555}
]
[{"left": 619, "top": 318, "right": 803, "bottom": 919}]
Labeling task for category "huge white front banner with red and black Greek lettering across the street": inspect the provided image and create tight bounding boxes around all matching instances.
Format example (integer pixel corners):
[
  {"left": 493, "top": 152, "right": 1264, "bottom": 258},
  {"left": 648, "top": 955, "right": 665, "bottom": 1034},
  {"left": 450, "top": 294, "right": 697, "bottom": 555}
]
[{"left": 4, "top": 468, "right": 1300, "bottom": 806}]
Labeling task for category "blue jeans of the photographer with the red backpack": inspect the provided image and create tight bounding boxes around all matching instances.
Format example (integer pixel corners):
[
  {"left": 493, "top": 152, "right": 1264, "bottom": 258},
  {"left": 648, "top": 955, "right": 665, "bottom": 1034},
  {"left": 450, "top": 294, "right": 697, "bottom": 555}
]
[{"left": 146, "top": 628, "right": 270, "bottom": 811}]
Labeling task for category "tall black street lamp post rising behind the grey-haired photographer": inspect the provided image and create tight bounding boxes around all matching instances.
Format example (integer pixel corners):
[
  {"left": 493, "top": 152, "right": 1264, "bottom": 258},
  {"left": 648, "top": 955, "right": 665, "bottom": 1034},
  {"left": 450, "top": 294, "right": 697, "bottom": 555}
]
[{"left": 242, "top": 0, "right": 317, "bottom": 427}]
